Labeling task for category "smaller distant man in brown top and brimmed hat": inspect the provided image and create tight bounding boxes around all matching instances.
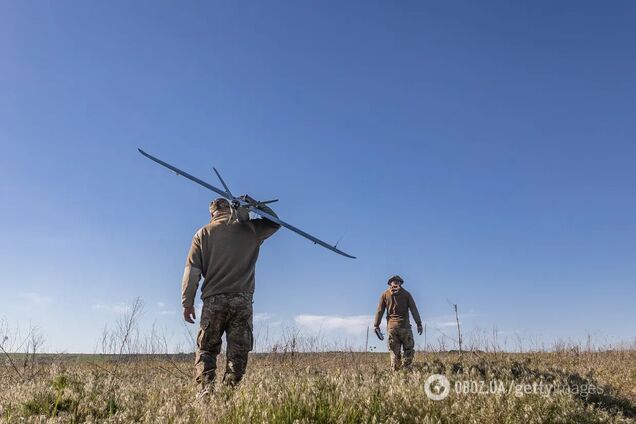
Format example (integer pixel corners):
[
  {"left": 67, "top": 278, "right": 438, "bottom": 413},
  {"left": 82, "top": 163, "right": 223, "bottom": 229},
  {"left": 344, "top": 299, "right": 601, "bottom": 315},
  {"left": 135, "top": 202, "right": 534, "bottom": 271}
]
[{"left": 373, "top": 275, "right": 422, "bottom": 371}]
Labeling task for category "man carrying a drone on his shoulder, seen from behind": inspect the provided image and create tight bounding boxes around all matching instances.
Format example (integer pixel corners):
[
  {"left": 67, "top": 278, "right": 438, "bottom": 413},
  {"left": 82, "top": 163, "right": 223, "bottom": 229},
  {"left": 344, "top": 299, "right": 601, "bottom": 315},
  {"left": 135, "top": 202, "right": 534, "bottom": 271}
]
[{"left": 181, "top": 196, "right": 280, "bottom": 397}]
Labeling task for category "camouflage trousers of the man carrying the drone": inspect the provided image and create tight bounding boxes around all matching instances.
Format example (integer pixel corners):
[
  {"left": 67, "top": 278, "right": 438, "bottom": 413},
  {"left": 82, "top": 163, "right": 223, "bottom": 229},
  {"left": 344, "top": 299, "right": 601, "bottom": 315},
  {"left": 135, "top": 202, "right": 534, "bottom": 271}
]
[{"left": 195, "top": 293, "right": 254, "bottom": 387}]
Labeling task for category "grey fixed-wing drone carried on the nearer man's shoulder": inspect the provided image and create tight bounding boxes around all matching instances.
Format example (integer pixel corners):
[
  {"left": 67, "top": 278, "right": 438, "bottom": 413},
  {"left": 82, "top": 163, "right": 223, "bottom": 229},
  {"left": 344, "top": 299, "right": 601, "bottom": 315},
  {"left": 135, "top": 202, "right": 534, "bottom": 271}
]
[{"left": 137, "top": 149, "right": 355, "bottom": 259}]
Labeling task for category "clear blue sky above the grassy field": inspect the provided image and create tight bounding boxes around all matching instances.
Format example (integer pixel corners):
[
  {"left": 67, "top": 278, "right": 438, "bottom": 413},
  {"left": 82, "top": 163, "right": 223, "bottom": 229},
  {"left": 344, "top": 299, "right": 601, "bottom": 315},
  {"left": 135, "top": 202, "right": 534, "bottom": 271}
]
[{"left": 0, "top": 0, "right": 636, "bottom": 352}]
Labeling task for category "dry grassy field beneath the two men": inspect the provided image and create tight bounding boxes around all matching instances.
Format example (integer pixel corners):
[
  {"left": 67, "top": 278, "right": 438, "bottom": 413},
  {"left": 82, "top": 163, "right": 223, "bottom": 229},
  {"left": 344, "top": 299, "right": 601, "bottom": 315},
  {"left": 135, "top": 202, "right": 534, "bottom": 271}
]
[{"left": 0, "top": 350, "right": 636, "bottom": 424}]
